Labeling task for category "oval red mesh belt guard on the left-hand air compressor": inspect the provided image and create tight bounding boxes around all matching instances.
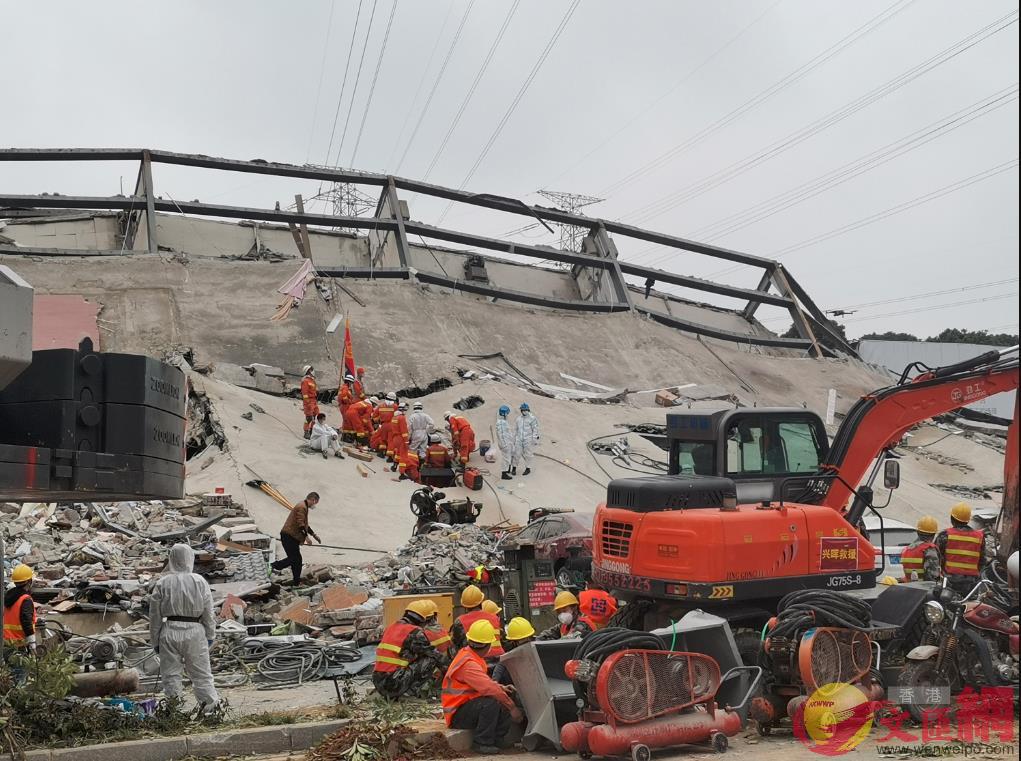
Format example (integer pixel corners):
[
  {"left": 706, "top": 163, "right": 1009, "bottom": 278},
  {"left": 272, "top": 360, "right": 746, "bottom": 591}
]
[{"left": 595, "top": 650, "right": 720, "bottom": 725}]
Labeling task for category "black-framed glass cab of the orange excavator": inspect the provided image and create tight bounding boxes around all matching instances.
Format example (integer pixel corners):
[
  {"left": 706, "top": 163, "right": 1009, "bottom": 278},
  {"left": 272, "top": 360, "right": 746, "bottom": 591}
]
[{"left": 667, "top": 408, "right": 829, "bottom": 504}]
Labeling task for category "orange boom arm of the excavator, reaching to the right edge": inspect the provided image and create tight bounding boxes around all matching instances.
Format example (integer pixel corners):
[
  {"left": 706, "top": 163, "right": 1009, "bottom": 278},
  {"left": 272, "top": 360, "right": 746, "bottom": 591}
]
[{"left": 820, "top": 346, "right": 1019, "bottom": 513}]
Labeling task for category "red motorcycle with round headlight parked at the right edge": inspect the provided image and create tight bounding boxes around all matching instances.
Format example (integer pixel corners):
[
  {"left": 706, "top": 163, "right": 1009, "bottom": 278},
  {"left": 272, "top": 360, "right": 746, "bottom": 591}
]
[{"left": 900, "top": 571, "right": 1019, "bottom": 721}]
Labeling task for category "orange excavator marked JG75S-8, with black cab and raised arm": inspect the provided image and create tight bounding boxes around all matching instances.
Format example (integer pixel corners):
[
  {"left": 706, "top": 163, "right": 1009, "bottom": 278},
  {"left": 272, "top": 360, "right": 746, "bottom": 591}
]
[{"left": 592, "top": 346, "right": 1018, "bottom": 633}]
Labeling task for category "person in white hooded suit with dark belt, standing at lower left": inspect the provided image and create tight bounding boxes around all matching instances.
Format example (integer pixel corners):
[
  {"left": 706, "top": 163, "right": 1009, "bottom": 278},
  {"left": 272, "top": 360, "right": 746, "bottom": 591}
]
[{"left": 149, "top": 544, "right": 220, "bottom": 710}]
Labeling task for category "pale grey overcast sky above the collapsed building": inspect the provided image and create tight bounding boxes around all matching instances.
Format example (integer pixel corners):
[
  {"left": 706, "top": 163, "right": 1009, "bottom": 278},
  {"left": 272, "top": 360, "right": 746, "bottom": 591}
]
[{"left": 0, "top": 0, "right": 1018, "bottom": 336}]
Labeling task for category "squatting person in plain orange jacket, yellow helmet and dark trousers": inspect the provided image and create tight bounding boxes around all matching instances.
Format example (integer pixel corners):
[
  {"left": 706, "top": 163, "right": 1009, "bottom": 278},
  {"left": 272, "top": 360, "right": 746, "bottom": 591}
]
[{"left": 440, "top": 621, "right": 525, "bottom": 754}]
